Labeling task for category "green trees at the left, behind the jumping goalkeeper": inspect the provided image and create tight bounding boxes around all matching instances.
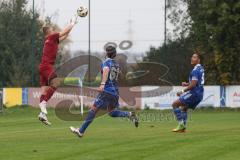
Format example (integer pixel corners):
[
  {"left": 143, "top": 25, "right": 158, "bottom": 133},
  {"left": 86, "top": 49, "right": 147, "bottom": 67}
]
[{"left": 0, "top": 0, "right": 69, "bottom": 87}]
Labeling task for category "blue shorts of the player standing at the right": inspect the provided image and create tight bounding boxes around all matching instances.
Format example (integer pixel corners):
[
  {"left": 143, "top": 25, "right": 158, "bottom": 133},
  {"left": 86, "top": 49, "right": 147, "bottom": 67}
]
[{"left": 179, "top": 92, "right": 203, "bottom": 109}]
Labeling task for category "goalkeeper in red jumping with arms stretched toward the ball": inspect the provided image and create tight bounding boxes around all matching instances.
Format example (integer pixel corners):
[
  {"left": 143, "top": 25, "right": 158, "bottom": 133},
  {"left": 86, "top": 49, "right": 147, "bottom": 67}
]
[{"left": 38, "top": 17, "right": 77, "bottom": 125}]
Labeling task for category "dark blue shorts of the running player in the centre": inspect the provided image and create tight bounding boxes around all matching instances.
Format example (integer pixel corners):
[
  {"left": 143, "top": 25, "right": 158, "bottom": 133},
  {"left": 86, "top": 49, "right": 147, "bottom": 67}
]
[{"left": 94, "top": 92, "right": 119, "bottom": 109}]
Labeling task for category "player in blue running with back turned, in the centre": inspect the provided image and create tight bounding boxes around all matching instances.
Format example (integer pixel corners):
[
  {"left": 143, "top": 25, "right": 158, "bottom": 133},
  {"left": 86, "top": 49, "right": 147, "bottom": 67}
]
[{"left": 70, "top": 46, "right": 138, "bottom": 137}]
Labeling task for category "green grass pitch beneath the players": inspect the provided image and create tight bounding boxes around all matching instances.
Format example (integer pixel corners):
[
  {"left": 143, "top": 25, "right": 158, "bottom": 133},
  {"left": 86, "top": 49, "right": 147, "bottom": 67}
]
[{"left": 0, "top": 107, "right": 240, "bottom": 160}]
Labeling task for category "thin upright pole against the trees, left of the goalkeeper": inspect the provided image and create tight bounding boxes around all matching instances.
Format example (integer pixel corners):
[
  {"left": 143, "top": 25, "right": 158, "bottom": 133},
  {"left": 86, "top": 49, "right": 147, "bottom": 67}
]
[{"left": 31, "top": 0, "right": 35, "bottom": 86}]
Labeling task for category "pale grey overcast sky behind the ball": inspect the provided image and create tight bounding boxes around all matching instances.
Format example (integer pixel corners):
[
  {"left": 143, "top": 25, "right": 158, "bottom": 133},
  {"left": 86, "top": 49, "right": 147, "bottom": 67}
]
[{"left": 29, "top": 0, "right": 164, "bottom": 54}]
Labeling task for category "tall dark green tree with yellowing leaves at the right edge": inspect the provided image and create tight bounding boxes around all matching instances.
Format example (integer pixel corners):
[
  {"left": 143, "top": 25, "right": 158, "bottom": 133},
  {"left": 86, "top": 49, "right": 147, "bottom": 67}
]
[{"left": 188, "top": 0, "right": 240, "bottom": 85}]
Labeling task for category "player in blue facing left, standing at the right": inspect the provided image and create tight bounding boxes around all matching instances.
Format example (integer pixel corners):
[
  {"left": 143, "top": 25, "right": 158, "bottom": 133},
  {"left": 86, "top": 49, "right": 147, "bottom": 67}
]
[{"left": 172, "top": 53, "right": 204, "bottom": 132}]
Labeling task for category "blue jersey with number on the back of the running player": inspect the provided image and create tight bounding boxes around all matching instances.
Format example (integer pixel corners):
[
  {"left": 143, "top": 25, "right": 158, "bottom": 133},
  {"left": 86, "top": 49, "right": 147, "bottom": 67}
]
[{"left": 101, "top": 58, "right": 120, "bottom": 96}]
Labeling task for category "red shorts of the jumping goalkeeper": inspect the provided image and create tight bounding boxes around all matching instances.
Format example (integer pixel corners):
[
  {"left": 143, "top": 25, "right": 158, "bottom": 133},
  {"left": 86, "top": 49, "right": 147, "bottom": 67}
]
[{"left": 39, "top": 65, "right": 57, "bottom": 86}]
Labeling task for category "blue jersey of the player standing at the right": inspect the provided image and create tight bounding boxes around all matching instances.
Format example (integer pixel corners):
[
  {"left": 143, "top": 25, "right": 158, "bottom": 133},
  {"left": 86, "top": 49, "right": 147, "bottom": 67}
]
[{"left": 189, "top": 64, "right": 204, "bottom": 97}]
